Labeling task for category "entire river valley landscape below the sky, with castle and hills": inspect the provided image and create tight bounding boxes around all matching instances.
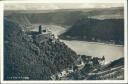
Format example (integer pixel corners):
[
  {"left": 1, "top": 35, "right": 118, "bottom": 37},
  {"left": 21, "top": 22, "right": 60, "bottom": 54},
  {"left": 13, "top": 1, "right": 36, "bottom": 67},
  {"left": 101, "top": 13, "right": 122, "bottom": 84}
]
[{"left": 4, "top": 7, "right": 124, "bottom": 80}]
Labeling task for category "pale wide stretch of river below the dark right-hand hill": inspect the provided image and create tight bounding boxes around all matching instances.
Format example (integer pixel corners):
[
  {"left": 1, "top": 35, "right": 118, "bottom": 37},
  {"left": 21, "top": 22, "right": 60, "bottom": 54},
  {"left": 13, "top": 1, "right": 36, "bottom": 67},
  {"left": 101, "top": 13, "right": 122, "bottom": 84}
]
[{"left": 61, "top": 40, "right": 124, "bottom": 63}]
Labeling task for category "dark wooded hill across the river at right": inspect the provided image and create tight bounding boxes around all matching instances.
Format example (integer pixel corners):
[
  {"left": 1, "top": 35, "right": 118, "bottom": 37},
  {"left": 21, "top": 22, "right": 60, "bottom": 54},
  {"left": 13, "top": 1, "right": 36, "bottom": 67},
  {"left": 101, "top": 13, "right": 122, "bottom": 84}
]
[{"left": 60, "top": 18, "right": 124, "bottom": 44}]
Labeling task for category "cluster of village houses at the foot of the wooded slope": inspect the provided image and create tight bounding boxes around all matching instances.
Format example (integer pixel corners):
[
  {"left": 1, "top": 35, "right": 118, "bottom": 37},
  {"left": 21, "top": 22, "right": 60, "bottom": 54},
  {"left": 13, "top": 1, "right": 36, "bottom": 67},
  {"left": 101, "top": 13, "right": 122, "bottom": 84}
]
[{"left": 51, "top": 55, "right": 105, "bottom": 80}]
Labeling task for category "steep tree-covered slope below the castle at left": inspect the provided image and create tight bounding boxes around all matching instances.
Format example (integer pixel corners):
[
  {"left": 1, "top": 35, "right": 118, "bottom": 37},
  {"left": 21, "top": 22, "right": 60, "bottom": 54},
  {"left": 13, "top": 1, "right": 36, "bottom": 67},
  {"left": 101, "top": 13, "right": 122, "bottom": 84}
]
[{"left": 4, "top": 20, "right": 77, "bottom": 80}]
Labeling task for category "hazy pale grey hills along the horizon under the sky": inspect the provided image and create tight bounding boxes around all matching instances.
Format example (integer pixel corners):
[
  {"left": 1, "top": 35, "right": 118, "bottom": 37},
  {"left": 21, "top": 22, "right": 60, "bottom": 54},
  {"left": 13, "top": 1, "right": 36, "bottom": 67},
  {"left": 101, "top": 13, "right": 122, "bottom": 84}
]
[{"left": 5, "top": 7, "right": 124, "bottom": 26}]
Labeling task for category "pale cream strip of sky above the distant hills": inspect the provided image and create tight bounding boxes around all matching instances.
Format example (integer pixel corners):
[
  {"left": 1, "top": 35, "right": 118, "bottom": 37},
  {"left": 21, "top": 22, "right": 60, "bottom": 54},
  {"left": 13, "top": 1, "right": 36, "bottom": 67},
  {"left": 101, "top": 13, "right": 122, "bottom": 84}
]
[{"left": 4, "top": 0, "right": 123, "bottom": 10}]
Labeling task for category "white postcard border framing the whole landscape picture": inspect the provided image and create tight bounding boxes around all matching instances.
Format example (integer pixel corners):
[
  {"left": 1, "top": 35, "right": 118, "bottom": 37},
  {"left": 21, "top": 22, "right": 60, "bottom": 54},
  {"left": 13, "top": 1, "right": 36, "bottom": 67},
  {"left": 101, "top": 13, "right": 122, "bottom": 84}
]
[{"left": 0, "top": 0, "right": 128, "bottom": 83}]
